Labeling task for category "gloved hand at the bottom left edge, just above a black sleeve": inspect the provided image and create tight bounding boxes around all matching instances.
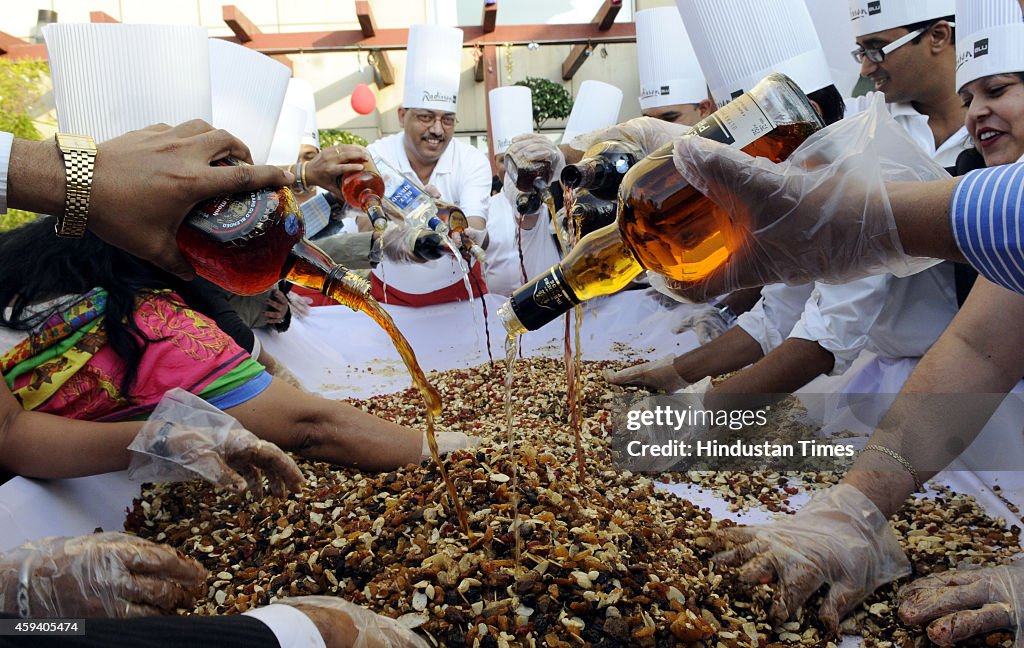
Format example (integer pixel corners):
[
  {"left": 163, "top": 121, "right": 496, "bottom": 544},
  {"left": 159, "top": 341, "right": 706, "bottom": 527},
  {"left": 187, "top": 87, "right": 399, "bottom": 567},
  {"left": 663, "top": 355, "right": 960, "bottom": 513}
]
[{"left": 0, "top": 532, "right": 207, "bottom": 618}]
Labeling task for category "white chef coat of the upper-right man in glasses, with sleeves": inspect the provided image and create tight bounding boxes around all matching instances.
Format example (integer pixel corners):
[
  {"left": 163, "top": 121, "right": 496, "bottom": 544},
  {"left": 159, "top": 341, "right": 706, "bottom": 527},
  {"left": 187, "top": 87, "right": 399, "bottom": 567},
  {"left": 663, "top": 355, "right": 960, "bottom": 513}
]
[{"left": 737, "top": 98, "right": 971, "bottom": 376}]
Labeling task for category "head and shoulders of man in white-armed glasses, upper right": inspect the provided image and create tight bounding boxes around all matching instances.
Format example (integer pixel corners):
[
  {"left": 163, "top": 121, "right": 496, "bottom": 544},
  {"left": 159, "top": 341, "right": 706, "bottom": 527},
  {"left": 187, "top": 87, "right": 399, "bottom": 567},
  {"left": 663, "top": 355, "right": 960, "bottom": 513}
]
[{"left": 849, "top": 0, "right": 970, "bottom": 169}]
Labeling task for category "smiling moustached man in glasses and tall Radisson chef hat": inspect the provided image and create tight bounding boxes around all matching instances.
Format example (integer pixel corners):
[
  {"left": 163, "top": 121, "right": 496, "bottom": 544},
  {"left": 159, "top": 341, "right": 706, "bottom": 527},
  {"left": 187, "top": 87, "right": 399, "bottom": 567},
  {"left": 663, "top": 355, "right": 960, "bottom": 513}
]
[{"left": 369, "top": 25, "right": 490, "bottom": 306}]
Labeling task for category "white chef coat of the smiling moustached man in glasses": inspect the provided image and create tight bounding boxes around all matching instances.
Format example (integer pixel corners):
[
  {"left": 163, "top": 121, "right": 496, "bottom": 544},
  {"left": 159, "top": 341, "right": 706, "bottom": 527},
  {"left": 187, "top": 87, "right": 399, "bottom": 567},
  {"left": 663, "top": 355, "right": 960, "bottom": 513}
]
[{"left": 368, "top": 132, "right": 490, "bottom": 295}]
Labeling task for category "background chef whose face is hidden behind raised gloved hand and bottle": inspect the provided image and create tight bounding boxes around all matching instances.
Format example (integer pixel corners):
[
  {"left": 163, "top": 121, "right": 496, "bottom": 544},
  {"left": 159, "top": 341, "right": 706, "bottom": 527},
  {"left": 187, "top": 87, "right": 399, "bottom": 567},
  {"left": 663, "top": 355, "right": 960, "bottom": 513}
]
[{"left": 484, "top": 86, "right": 559, "bottom": 296}]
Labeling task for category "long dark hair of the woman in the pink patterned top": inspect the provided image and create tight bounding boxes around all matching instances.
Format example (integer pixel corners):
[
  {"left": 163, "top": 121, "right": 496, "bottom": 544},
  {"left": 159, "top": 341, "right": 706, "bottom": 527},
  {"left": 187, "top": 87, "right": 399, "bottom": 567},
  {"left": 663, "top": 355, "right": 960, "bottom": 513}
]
[{"left": 0, "top": 216, "right": 168, "bottom": 394}]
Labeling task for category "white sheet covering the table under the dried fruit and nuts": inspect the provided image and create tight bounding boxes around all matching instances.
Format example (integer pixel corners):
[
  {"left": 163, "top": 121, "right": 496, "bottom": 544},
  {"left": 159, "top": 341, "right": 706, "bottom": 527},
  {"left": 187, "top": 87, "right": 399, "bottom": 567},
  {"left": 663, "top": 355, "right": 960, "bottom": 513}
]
[{"left": 0, "top": 291, "right": 1024, "bottom": 647}]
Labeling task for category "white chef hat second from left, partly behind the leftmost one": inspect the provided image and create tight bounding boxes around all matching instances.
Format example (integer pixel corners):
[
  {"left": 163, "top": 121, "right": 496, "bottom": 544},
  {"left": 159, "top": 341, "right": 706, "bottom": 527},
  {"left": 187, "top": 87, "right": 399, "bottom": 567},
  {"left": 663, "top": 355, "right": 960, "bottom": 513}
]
[{"left": 210, "top": 38, "right": 292, "bottom": 164}]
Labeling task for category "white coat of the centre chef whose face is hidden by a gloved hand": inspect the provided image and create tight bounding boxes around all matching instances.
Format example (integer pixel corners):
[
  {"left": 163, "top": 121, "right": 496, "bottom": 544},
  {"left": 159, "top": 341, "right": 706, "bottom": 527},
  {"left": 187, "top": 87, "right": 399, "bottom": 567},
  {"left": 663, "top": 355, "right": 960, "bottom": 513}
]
[{"left": 483, "top": 191, "right": 561, "bottom": 296}]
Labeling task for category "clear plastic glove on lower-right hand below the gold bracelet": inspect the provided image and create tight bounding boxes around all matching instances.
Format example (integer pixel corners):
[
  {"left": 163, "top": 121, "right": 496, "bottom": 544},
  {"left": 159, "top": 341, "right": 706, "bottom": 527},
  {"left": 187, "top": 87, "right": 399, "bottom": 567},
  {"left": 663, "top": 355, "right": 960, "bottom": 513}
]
[{"left": 715, "top": 484, "right": 910, "bottom": 635}]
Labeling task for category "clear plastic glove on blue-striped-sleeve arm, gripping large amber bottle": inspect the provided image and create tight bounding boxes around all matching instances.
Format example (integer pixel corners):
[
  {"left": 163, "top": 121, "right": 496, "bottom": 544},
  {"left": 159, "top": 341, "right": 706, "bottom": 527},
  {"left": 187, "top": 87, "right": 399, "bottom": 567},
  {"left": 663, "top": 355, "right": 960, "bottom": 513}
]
[{"left": 674, "top": 96, "right": 949, "bottom": 301}]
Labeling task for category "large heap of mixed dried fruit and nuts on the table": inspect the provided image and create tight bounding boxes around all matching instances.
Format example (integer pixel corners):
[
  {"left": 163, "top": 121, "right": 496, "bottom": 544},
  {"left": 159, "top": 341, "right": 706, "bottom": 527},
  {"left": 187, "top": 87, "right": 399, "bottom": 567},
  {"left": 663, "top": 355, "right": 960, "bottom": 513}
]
[{"left": 125, "top": 358, "right": 1019, "bottom": 648}]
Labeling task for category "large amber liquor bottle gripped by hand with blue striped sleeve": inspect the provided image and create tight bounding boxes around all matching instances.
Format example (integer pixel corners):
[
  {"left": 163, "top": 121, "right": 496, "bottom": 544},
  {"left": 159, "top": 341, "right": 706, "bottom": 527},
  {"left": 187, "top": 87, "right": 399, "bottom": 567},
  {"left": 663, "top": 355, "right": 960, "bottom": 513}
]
[{"left": 499, "top": 74, "right": 823, "bottom": 334}]
